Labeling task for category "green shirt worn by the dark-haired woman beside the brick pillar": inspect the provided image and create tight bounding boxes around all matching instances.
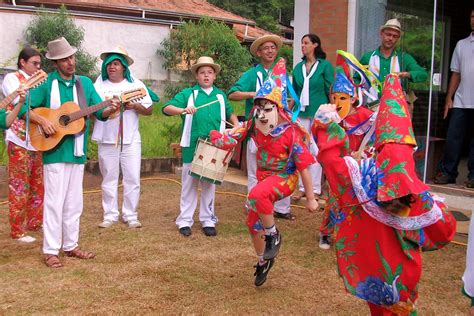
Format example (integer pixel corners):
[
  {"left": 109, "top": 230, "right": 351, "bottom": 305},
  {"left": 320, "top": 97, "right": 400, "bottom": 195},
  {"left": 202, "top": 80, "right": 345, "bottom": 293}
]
[{"left": 293, "top": 59, "right": 334, "bottom": 118}]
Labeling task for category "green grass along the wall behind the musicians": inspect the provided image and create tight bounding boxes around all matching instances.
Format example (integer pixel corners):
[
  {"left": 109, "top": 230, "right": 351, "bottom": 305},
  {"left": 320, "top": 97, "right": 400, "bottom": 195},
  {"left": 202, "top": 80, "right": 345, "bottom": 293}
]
[{"left": 0, "top": 102, "right": 244, "bottom": 165}]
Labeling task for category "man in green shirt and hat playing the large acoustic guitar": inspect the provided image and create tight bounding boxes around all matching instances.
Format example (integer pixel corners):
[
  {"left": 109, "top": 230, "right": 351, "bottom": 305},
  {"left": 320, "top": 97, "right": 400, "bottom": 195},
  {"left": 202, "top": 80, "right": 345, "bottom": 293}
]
[{"left": 24, "top": 37, "right": 120, "bottom": 268}]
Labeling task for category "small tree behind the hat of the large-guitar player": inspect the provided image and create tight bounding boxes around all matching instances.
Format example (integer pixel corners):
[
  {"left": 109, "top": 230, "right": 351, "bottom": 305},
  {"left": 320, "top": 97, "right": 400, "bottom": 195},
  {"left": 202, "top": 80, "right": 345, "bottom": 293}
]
[{"left": 25, "top": 5, "right": 99, "bottom": 78}]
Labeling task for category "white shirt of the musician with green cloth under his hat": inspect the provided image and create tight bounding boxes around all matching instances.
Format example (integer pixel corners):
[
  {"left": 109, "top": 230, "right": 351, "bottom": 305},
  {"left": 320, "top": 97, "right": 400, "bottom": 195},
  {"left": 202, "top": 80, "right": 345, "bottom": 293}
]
[{"left": 92, "top": 76, "right": 153, "bottom": 145}]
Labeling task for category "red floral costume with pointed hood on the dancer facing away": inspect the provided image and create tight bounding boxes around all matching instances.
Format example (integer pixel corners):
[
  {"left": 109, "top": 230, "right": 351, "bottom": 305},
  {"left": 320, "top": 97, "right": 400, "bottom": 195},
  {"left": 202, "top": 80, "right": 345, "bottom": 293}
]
[{"left": 313, "top": 75, "right": 456, "bottom": 315}]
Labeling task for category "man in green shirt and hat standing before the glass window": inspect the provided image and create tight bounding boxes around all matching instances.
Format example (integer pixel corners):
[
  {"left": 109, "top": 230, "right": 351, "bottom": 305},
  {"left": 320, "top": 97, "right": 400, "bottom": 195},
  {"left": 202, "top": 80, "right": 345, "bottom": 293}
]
[{"left": 360, "top": 19, "right": 428, "bottom": 97}]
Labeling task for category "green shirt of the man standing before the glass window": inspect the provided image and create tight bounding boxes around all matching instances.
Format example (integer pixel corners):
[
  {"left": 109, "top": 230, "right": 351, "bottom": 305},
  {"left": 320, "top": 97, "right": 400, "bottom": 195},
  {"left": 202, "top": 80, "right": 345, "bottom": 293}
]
[{"left": 360, "top": 47, "right": 428, "bottom": 91}]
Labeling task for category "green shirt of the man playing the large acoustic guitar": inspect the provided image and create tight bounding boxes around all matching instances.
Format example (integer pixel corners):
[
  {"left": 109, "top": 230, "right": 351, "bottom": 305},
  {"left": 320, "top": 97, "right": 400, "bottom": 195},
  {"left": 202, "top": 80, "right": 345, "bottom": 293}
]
[{"left": 19, "top": 71, "right": 107, "bottom": 165}]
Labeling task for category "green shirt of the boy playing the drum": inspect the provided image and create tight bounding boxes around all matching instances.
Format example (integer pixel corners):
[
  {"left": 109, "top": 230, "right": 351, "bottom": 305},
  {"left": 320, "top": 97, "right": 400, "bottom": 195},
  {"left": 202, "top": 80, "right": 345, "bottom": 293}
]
[{"left": 162, "top": 85, "right": 233, "bottom": 163}]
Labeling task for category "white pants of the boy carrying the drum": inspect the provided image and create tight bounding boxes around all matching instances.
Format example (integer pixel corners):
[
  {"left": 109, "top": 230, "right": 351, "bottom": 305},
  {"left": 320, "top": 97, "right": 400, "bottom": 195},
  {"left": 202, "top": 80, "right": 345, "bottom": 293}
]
[{"left": 176, "top": 163, "right": 218, "bottom": 228}]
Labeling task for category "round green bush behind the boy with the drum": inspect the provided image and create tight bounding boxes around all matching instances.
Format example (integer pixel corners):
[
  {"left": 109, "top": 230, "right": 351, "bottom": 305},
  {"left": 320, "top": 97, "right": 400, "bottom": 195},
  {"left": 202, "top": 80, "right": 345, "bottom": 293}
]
[{"left": 157, "top": 18, "right": 250, "bottom": 97}]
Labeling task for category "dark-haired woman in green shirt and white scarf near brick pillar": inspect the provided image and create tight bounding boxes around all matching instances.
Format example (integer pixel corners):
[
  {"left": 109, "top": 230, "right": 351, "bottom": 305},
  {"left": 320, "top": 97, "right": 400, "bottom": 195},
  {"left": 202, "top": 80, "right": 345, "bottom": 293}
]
[{"left": 292, "top": 34, "right": 334, "bottom": 201}]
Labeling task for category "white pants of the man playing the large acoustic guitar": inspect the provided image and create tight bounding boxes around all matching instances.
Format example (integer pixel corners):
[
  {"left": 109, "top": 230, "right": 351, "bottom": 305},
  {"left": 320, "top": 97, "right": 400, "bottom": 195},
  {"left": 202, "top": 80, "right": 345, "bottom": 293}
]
[{"left": 43, "top": 163, "right": 84, "bottom": 255}]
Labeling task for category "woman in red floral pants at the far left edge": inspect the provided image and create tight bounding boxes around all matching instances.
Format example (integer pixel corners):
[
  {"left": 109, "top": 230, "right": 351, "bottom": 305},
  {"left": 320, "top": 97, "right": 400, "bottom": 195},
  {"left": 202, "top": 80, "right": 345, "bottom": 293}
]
[{"left": 2, "top": 47, "right": 44, "bottom": 243}]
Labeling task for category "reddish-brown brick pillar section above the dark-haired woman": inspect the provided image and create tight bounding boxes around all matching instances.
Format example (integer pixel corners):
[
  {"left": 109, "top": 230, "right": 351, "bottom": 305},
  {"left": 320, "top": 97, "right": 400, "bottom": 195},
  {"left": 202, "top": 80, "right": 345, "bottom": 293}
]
[{"left": 309, "top": 0, "right": 348, "bottom": 65}]
